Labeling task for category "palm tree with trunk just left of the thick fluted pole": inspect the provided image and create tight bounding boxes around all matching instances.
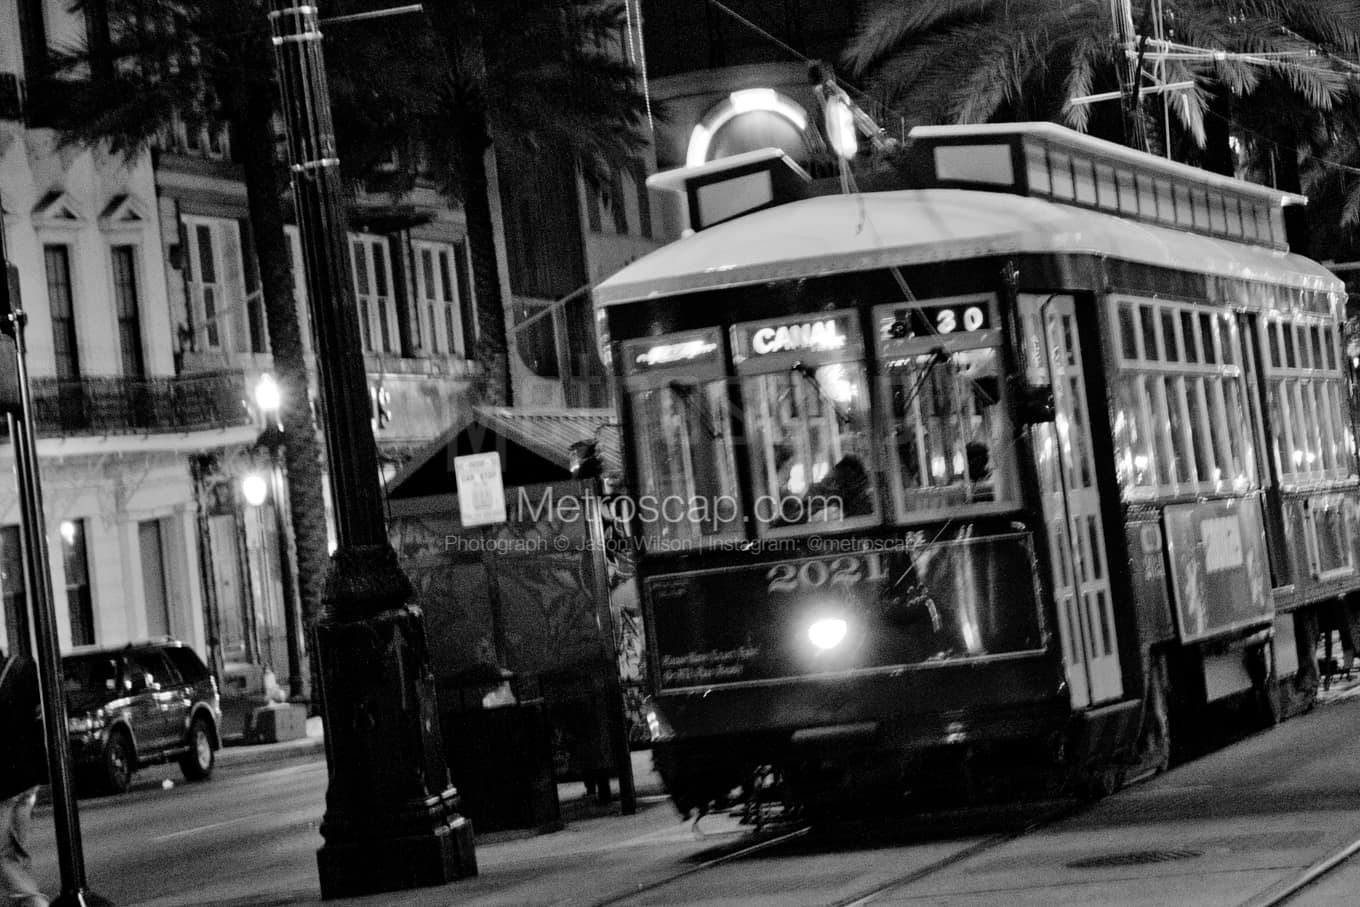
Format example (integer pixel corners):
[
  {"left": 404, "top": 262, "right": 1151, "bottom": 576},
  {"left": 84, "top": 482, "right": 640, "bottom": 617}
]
[{"left": 46, "top": 0, "right": 345, "bottom": 699}]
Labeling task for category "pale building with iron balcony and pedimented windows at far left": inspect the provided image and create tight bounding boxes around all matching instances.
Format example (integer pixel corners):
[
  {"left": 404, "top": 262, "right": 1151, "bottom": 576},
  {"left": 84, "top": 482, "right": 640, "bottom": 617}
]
[{"left": 0, "top": 0, "right": 257, "bottom": 666}]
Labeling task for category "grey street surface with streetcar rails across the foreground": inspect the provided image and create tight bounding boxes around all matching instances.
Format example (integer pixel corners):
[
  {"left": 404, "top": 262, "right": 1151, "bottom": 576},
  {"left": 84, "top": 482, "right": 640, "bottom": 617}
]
[{"left": 21, "top": 689, "right": 1360, "bottom": 907}]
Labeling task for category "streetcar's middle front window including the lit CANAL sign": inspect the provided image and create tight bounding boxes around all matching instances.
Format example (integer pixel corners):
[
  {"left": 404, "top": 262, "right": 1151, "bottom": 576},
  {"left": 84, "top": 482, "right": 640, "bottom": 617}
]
[{"left": 732, "top": 311, "right": 879, "bottom": 536}]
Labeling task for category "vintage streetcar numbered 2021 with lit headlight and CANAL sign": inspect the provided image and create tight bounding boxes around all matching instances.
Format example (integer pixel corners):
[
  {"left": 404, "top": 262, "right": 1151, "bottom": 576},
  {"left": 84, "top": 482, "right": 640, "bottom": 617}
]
[{"left": 594, "top": 124, "right": 1360, "bottom": 815}]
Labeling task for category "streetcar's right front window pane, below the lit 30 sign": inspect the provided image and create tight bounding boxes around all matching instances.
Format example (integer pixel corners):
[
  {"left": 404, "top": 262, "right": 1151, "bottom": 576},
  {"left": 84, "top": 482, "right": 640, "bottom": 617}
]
[{"left": 885, "top": 347, "right": 1016, "bottom": 519}]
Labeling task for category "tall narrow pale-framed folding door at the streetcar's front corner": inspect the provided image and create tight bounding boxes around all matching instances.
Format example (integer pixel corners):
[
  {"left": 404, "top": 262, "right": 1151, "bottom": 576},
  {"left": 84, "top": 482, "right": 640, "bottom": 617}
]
[{"left": 1020, "top": 295, "right": 1123, "bottom": 706}]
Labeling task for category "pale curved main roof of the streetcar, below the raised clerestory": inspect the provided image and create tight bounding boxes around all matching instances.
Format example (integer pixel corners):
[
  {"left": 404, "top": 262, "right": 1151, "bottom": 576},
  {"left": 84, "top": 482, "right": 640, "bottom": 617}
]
[{"left": 594, "top": 189, "right": 1342, "bottom": 307}]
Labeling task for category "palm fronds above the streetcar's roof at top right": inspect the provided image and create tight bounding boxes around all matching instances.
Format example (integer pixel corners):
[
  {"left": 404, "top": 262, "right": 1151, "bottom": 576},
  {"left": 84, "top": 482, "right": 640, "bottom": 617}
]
[{"left": 845, "top": 0, "right": 1360, "bottom": 171}]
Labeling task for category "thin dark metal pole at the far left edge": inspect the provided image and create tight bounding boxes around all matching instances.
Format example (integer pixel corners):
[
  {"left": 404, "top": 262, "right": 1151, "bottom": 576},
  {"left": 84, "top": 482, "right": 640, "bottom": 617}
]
[{"left": 0, "top": 228, "right": 110, "bottom": 907}]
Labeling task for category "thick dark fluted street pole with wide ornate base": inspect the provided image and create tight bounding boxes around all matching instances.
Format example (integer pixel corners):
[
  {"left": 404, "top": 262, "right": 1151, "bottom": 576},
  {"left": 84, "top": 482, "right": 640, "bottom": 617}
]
[{"left": 269, "top": 0, "right": 477, "bottom": 899}]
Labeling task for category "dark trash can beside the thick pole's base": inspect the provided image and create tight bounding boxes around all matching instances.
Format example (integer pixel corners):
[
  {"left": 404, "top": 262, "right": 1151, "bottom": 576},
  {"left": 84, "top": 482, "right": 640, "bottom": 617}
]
[{"left": 439, "top": 666, "right": 562, "bottom": 834}]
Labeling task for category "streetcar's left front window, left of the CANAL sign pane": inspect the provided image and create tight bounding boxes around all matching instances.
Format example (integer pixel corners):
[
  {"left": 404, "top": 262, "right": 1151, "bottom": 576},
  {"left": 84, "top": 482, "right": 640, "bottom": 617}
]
[{"left": 624, "top": 329, "right": 743, "bottom": 552}]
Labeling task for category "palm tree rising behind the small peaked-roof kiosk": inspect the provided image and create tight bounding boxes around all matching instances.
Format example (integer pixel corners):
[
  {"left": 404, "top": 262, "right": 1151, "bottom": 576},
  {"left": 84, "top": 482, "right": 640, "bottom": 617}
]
[{"left": 426, "top": 0, "right": 646, "bottom": 404}]
